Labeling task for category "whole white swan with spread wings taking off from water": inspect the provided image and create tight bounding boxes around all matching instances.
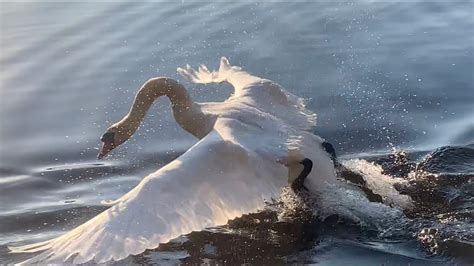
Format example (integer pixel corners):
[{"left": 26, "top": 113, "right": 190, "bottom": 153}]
[{"left": 10, "top": 57, "right": 335, "bottom": 263}]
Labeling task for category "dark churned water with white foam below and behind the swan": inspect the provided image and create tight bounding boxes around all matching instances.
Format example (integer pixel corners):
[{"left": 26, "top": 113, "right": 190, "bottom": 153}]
[{"left": 132, "top": 146, "right": 474, "bottom": 265}]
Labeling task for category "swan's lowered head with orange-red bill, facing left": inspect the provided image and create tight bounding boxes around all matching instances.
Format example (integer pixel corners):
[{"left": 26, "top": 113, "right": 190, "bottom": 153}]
[{"left": 97, "top": 122, "right": 136, "bottom": 159}]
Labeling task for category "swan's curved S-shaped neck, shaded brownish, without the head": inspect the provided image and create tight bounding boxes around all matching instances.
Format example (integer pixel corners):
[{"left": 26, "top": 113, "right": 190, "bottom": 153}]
[{"left": 119, "top": 78, "right": 212, "bottom": 138}]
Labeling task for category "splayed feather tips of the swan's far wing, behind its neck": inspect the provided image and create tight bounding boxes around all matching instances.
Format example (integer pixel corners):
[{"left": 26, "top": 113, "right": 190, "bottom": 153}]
[{"left": 177, "top": 57, "right": 242, "bottom": 84}]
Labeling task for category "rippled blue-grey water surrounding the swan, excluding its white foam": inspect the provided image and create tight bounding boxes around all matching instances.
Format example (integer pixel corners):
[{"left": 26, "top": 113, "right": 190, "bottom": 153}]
[{"left": 0, "top": 1, "right": 474, "bottom": 265}]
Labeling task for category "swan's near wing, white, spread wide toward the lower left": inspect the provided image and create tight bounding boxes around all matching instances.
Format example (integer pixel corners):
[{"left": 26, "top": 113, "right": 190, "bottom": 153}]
[{"left": 11, "top": 118, "right": 287, "bottom": 263}]
